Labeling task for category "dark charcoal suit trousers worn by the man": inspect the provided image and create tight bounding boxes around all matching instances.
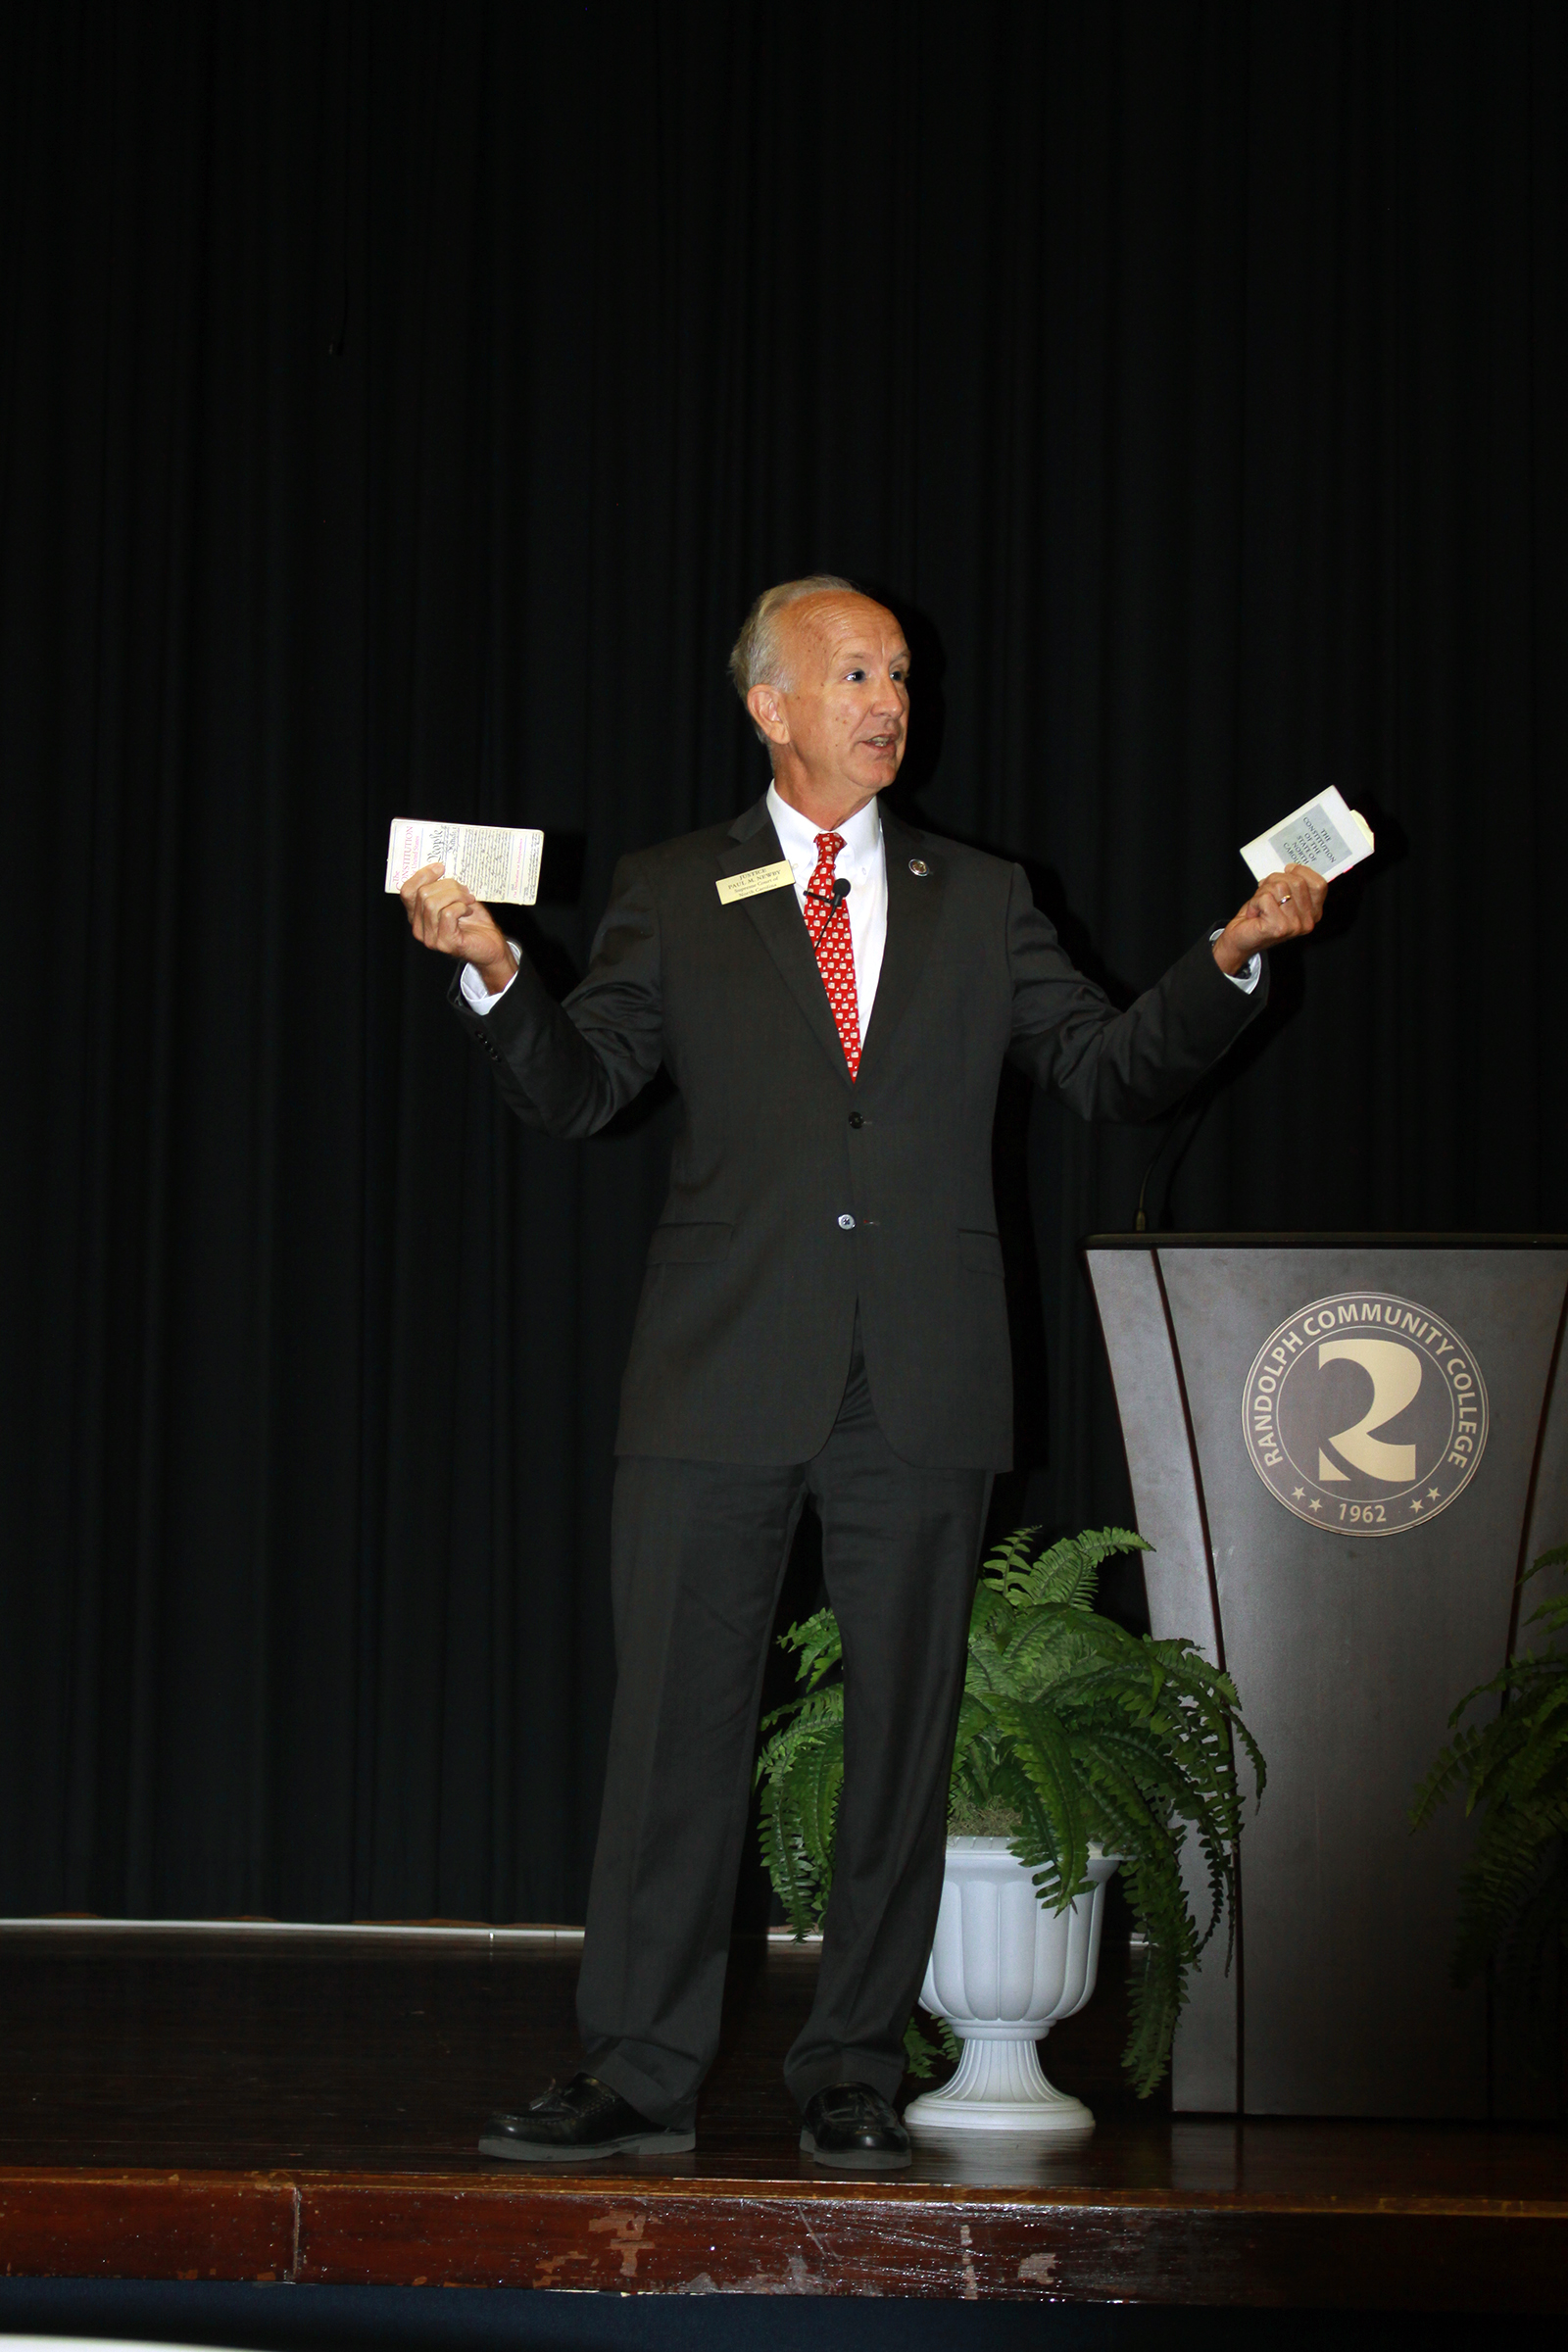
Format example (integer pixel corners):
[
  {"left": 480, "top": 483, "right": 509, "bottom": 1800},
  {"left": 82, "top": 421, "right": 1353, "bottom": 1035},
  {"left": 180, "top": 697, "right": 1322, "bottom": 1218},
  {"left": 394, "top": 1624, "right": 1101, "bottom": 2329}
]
[{"left": 578, "top": 1327, "right": 992, "bottom": 2127}]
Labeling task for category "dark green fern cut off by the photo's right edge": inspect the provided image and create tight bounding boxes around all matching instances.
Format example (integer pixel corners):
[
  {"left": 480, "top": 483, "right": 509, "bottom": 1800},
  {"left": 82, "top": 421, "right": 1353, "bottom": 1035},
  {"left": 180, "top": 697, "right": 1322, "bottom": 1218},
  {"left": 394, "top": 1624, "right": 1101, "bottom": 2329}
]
[{"left": 1410, "top": 1543, "right": 1568, "bottom": 1999}]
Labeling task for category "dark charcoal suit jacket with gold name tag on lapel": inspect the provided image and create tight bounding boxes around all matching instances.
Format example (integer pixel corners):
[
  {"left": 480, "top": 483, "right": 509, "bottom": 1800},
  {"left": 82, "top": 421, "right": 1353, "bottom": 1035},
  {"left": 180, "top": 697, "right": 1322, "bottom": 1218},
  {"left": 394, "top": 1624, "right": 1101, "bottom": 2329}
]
[{"left": 454, "top": 800, "right": 1265, "bottom": 1470}]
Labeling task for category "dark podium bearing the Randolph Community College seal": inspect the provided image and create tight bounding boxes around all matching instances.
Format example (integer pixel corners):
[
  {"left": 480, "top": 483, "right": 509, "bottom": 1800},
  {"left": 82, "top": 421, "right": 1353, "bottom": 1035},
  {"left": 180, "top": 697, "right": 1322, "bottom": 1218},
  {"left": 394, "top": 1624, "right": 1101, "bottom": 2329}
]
[{"left": 1084, "top": 1233, "right": 1568, "bottom": 2117}]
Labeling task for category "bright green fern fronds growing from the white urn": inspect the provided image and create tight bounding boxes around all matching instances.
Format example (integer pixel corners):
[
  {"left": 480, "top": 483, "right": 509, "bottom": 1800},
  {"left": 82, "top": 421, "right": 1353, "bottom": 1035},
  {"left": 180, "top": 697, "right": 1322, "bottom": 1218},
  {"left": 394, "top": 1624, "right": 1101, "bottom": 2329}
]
[{"left": 757, "top": 1527, "right": 1265, "bottom": 2098}]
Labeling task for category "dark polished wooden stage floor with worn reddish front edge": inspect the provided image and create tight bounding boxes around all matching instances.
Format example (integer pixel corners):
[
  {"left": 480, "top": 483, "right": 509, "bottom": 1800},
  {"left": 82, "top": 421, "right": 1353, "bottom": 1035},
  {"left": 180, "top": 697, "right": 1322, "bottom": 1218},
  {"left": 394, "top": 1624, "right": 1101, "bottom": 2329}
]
[{"left": 0, "top": 1927, "right": 1568, "bottom": 2312}]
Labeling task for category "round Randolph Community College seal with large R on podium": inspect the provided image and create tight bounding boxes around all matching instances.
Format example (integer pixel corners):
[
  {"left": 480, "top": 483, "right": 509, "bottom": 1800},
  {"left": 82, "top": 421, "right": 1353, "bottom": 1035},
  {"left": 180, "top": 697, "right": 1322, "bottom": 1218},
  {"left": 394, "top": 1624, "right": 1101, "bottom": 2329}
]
[{"left": 1242, "top": 1292, "right": 1486, "bottom": 1536}]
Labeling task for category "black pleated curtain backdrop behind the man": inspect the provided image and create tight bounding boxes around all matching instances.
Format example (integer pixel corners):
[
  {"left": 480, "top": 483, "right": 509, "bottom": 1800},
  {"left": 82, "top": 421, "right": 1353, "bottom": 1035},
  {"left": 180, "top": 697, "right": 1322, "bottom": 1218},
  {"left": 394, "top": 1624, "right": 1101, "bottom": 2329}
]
[{"left": 0, "top": 0, "right": 1568, "bottom": 1919}]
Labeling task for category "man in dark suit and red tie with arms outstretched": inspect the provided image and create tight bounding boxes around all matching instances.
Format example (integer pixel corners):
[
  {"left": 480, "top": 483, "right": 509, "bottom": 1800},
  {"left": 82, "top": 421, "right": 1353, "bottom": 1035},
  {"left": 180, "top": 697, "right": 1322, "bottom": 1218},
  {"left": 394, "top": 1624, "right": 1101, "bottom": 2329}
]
[{"left": 402, "top": 576, "right": 1324, "bottom": 2171}]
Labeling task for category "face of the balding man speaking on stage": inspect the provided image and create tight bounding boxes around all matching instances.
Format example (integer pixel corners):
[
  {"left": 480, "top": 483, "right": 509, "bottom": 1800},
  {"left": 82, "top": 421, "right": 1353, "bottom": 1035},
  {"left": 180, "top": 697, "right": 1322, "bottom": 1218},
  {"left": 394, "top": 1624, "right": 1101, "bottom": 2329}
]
[{"left": 753, "top": 595, "right": 909, "bottom": 800}]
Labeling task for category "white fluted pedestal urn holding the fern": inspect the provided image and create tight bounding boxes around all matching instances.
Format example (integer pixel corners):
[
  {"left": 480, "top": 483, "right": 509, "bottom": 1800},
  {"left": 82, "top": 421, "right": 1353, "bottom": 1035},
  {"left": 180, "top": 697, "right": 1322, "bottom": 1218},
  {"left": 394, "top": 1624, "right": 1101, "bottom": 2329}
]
[{"left": 903, "top": 1837, "right": 1116, "bottom": 2140}]
